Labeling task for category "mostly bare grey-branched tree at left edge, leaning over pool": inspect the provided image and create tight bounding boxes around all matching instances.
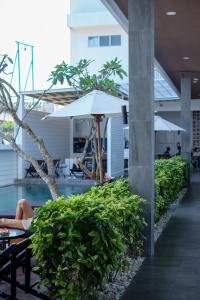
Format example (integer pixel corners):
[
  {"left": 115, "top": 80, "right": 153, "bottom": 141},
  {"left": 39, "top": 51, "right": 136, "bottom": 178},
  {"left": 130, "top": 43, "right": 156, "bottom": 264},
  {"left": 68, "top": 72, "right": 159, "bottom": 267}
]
[{"left": 0, "top": 55, "right": 59, "bottom": 199}]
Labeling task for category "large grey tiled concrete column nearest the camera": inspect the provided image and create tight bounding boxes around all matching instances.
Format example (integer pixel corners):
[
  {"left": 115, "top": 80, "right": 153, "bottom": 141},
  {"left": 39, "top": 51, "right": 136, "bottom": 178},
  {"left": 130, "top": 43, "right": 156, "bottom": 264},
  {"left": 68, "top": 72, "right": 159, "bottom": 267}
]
[{"left": 128, "top": 0, "right": 154, "bottom": 256}]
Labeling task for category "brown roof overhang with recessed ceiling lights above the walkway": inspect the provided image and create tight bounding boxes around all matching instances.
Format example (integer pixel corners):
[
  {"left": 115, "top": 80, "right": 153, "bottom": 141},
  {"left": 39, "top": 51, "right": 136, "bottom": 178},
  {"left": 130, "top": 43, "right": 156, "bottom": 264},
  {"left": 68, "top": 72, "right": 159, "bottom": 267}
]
[{"left": 101, "top": 0, "right": 200, "bottom": 99}]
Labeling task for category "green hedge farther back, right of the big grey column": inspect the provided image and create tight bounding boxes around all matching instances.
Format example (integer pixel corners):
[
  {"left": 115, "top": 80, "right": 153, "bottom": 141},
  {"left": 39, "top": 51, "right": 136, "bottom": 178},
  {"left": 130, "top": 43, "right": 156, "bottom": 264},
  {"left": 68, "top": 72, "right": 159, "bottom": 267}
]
[{"left": 155, "top": 156, "right": 186, "bottom": 221}]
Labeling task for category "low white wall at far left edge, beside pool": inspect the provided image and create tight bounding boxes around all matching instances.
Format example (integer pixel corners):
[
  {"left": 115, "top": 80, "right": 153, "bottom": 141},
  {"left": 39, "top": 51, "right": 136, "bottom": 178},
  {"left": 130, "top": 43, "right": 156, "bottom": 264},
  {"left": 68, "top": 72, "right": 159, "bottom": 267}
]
[{"left": 0, "top": 150, "right": 17, "bottom": 186}]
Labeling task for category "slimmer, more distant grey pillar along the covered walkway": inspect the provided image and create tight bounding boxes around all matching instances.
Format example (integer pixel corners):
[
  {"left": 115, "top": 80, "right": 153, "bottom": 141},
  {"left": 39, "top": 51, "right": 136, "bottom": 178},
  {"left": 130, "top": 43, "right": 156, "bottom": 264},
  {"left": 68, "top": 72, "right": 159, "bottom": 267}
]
[{"left": 181, "top": 72, "right": 192, "bottom": 184}]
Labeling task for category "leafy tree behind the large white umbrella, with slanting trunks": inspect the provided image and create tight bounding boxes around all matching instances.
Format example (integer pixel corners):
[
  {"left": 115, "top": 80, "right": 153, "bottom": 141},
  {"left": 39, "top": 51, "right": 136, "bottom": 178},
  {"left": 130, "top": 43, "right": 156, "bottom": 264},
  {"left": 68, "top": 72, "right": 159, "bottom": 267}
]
[{"left": 49, "top": 58, "right": 127, "bottom": 181}]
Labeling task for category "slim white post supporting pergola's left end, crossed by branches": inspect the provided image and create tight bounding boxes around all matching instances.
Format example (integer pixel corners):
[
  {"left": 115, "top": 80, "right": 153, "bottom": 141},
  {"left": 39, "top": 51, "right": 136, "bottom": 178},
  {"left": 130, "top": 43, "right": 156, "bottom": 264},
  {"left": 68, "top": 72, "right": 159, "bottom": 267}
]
[{"left": 15, "top": 95, "right": 25, "bottom": 179}]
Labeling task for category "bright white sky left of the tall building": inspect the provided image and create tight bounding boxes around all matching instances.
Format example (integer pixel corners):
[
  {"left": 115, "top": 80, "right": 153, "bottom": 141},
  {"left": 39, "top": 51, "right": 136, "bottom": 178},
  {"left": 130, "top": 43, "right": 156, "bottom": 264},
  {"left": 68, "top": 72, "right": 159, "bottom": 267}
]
[{"left": 0, "top": 0, "right": 70, "bottom": 90}]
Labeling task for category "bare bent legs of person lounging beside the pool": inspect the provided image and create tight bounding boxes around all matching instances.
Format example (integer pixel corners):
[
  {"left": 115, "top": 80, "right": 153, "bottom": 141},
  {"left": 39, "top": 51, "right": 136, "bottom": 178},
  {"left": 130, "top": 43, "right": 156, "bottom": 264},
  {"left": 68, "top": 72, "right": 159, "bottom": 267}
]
[{"left": 0, "top": 199, "right": 34, "bottom": 230}]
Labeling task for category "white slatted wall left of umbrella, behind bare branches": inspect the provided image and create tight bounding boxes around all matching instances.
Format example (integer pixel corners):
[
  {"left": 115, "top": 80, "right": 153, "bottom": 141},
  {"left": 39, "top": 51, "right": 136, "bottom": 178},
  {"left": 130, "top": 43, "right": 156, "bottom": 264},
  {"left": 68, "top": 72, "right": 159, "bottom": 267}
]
[{"left": 23, "top": 111, "right": 71, "bottom": 176}]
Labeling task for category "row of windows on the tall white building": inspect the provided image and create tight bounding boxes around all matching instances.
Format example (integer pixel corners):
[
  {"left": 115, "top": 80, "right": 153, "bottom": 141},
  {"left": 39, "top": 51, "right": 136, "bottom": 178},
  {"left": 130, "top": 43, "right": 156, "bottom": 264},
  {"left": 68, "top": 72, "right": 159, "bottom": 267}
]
[{"left": 88, "top": 35, "right": 121, "bottom": 47}]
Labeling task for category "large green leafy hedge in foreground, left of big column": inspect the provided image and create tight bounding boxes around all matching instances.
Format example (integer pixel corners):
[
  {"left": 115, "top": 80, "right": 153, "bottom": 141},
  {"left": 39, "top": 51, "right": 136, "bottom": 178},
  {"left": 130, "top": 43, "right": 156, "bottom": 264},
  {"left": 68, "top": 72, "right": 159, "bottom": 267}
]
[{"left": 32, "top": 179, "right": 145, "bottom": 300}]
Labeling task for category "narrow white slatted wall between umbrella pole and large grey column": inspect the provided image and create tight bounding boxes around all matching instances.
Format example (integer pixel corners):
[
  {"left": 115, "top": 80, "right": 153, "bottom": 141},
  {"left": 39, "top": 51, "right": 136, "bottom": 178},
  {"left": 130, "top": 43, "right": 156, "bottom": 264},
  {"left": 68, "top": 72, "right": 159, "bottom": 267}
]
[{"left": 107, "top": 116, "right": 124, "bottom": 177}]
